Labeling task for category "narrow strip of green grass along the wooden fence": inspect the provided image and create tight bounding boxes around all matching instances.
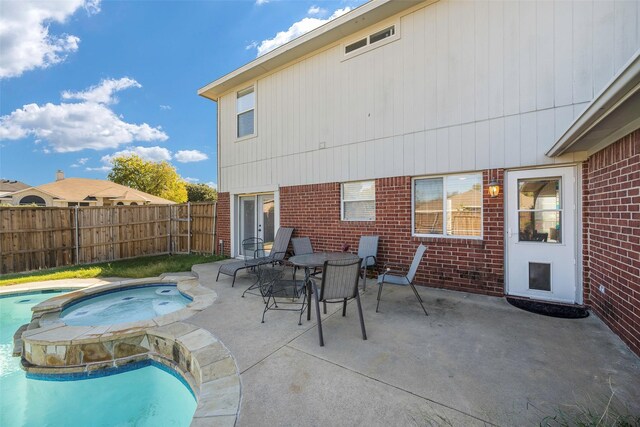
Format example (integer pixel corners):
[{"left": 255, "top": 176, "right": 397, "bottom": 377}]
[{"left": 0, "top": 255, "right": 223, "bottom": 286}]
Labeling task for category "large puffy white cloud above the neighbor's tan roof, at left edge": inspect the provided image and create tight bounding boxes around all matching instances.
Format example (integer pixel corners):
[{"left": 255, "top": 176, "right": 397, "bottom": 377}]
[{"left": 0, "top": 78, "right": 169, "bottom": 153}]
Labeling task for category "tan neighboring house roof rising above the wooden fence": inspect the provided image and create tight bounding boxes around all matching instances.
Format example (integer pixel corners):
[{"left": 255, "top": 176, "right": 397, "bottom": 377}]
[{"left": 8, "top": 178, "right": 175, "bottom": 205}]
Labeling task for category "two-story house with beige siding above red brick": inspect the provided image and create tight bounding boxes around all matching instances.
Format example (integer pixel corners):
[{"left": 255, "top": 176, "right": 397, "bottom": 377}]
[{"left": 199, "top": 0, "right": 640, "bottom": 354}]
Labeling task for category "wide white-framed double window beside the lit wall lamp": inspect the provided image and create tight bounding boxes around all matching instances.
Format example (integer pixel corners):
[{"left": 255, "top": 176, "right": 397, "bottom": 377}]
[{"left": 412, "top": 172, "right": 483, "bottom": 239}]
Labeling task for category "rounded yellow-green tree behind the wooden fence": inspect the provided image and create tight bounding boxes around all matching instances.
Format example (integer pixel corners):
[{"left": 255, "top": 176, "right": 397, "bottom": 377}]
[{"left": 107, "top": 154, "right": 187, "bottom": 203}]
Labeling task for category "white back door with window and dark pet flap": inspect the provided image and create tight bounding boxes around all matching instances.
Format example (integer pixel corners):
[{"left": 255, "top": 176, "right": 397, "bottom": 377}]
[{"left": 505, "top": 167, "right": 580, "bottom": 303}]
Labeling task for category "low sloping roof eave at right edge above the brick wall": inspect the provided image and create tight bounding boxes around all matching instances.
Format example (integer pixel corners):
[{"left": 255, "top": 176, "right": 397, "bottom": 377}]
[{"left": 547, "top": 50, "right": 640, "bottom": 157}]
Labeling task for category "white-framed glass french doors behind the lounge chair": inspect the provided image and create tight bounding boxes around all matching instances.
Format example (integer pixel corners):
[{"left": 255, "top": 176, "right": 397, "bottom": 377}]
[{"left": 237, "top": 193, "right": 275, "bottom": 256}]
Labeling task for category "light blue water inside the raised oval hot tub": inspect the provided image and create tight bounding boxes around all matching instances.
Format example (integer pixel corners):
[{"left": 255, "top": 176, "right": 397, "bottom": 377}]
[{"left": 60, "top": 285, "right": 191, "bottom": 326}]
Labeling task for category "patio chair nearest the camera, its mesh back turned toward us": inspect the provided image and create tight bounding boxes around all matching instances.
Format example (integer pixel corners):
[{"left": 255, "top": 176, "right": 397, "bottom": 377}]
[{"left": 311, "top": 258, "right": 367, "bottom": 347}]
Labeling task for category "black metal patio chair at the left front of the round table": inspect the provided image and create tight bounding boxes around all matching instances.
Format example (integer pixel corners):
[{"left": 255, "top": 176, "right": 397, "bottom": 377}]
[{"left": 256, "top": 264, "right": 307, "bottom": 325}]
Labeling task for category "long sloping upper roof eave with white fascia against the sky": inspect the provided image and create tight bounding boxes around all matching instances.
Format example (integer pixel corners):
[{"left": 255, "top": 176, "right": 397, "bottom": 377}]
[{"left": 198, "top": 0, "right": 428, "bottom": 101}]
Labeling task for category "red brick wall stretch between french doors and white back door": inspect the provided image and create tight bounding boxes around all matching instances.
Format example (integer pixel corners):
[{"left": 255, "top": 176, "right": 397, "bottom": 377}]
[{"left": 280, "top": 170, "right": 504, "bottom": 296}]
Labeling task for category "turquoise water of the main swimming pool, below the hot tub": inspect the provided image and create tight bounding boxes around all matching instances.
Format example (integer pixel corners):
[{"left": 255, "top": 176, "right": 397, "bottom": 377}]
[{"left": 0, "top": 293, "right": 196, "bottom": 427}]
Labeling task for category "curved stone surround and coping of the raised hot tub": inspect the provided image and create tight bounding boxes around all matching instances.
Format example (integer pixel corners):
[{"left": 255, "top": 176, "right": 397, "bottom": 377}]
[{"left": 15, "top": 275, "right": 241, "bottom": 426}]
